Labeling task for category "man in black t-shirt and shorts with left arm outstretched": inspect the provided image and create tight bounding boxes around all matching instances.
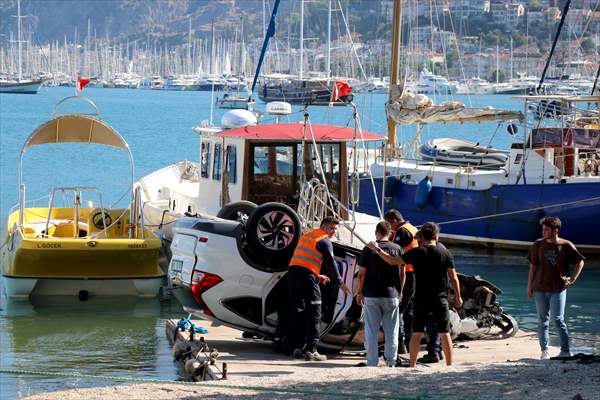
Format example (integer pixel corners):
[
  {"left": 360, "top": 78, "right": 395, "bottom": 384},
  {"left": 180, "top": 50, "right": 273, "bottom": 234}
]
[{"left": 369, "top": 222, "right": 462, "bottom": 367}]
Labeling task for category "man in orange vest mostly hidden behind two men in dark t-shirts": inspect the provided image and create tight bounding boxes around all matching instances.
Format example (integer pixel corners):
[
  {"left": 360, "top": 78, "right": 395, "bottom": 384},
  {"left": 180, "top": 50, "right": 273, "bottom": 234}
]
[{"left": 384, "top": 209, "right": 443, "bottom": 363}]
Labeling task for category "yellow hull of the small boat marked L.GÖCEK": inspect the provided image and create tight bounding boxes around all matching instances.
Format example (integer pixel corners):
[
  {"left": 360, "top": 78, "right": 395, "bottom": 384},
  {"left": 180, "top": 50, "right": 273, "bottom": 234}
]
[{"left": 1, "top": 231, "right": 165, "bottom": 298}]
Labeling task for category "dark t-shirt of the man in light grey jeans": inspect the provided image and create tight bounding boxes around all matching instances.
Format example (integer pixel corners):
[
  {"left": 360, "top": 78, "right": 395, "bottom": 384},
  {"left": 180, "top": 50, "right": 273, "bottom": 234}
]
[{"left": 358, "top": 240, "right": 402, "bottom": 297}]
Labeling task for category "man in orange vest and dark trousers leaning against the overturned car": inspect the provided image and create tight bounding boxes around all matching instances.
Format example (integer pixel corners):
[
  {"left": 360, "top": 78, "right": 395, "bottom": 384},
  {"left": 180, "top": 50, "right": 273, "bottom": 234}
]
[{"left": 288, "top": 217, "right": 350, "bottom": 361}]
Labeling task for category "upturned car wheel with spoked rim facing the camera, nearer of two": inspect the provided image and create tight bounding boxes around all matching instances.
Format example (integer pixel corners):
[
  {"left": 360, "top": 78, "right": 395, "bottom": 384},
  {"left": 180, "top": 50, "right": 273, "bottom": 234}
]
[{"left": 246, "top": 203, "right": 301, "bottom": 263}]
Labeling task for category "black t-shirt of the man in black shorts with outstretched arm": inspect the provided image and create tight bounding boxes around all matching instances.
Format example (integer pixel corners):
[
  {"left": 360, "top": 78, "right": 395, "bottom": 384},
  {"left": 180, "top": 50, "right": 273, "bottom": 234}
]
[{"left": 402, "top": 243, "right": 454, "bottom": 300}]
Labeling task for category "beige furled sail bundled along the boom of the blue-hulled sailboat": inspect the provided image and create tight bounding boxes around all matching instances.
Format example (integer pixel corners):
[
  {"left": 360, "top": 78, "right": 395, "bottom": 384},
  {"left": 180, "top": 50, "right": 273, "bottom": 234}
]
[{"left": 387, "top": 86, "right": 523, "bottom": 124}]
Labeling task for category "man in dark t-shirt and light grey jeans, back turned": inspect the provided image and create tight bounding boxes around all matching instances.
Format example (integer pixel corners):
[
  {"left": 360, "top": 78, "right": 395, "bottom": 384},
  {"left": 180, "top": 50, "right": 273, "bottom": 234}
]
[{"left": 356, "top": 221, "right": 404, "bottom": 367}]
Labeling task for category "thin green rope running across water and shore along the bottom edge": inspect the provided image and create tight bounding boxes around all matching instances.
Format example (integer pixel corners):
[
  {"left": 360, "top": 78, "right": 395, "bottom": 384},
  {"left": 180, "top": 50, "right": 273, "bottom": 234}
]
[{"left": 0, "top": 368, "right": 437, "bottom": 400}]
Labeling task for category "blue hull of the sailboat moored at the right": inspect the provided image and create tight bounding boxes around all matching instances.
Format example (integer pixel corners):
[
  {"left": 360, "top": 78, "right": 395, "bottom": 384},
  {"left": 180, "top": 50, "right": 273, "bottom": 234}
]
[{"left": 359, "top": 178, "right": 600, "bottom": 250}]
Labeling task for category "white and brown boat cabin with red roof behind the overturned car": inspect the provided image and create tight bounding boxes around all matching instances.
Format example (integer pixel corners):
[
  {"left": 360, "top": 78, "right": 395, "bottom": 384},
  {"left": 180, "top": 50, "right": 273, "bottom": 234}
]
[{"left": 188, "top": 123, "right": 382, "bottom": 215}]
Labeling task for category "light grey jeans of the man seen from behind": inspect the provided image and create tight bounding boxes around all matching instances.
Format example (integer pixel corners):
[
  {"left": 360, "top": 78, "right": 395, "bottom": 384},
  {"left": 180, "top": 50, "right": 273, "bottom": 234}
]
[{"left": 363, "top": 297, "right": 400, "bottom": 367}]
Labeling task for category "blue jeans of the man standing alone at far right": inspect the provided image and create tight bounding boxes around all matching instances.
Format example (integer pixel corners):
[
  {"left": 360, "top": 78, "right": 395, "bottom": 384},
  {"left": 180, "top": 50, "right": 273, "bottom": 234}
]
[{"left": 533, "top": 290, "right": 570, "bottom": 352}]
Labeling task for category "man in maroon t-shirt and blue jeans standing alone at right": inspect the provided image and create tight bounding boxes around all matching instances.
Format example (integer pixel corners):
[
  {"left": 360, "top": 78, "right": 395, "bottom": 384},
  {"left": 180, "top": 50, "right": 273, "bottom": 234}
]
[{"left": 527, "top": 217, "right": 584, "bottom": 360}]
